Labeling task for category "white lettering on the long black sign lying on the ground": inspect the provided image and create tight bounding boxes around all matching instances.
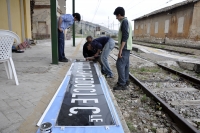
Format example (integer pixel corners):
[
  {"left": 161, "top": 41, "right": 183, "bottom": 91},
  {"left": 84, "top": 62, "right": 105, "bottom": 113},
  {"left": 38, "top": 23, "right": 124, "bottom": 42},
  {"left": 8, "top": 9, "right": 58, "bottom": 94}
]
[{"left": 69, "top": 62, "right": 103, "bottom": 122}]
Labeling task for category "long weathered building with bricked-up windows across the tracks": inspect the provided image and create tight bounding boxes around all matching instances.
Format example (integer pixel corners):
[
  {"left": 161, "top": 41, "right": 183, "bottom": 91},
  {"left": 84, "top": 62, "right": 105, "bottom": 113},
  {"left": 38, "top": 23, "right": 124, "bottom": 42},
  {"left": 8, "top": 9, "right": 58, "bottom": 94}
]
[{"left": 133, "top": 0, "right": 200, "bottom": 48}]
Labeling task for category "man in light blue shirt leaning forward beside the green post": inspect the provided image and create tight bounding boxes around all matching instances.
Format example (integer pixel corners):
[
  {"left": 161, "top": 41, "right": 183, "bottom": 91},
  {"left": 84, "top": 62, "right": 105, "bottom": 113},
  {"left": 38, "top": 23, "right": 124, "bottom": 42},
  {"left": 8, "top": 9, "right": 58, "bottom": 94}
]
[{"left": 58, "top": 13, "right": 81, "bottom": 62}]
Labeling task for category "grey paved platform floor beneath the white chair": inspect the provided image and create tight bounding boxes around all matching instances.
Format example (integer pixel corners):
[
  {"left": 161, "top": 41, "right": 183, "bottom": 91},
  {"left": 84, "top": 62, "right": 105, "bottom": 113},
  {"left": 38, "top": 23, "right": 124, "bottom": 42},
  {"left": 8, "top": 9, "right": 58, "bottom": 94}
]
[{"left": 0, "top": 38, "right": 85, "bottom": 133}]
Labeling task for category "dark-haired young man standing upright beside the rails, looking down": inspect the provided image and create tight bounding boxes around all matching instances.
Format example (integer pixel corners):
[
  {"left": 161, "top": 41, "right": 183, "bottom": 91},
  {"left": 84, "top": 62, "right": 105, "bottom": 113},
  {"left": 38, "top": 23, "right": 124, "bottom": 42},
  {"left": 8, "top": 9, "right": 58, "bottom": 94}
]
[{"left": 113, "top": 7, "right": 132, "bottom": 90}]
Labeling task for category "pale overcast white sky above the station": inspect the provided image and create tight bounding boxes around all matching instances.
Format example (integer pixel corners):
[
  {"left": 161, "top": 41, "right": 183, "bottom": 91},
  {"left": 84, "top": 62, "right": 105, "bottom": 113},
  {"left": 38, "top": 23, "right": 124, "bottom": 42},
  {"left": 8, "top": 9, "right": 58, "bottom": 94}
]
[{"left": 66, "top": 0, "right": 185, "bottom": 30}]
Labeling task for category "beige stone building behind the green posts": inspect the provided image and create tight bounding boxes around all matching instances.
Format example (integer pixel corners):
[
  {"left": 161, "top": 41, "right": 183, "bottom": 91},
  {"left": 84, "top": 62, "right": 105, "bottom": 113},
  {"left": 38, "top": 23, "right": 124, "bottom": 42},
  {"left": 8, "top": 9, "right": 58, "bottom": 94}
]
[{"left": 32, "top": 0, "right": 66, "bottom": 39}]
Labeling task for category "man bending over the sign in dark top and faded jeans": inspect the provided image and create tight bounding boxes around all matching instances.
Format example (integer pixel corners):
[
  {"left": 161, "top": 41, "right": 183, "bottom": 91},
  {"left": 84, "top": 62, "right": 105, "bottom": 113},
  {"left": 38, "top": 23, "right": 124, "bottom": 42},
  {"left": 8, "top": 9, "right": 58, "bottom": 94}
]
[{"left": 87, "top": 37, "right": 115, "bottom": 78}]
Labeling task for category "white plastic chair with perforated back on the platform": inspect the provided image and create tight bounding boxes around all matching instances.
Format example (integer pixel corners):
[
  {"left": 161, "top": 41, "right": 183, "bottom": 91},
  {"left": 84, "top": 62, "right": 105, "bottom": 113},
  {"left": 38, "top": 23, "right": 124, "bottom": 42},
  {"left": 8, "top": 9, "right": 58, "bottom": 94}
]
[{"left": 0, "top": 29, "right": 20, "bottom": 85}]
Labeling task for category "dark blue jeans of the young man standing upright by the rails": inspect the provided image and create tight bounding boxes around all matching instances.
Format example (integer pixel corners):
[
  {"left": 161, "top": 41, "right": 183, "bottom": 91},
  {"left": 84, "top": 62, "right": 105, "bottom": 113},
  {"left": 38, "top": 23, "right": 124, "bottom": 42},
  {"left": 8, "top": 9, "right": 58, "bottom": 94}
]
[{"left": 116, "top": 50, "right": 130, "bottom": 85}]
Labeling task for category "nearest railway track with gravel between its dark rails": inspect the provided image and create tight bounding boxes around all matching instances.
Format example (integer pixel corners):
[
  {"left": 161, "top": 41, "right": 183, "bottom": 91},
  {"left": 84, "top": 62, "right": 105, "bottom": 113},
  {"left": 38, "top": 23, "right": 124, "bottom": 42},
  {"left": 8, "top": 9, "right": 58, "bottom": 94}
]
[{"left": 108, "top": 48, "right": 200, "bottom": 133}]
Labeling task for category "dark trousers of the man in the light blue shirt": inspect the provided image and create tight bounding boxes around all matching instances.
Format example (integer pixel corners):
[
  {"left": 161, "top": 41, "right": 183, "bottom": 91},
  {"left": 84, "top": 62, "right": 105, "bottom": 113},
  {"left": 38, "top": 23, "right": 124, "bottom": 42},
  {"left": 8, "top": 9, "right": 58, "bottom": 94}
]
[{"left": 58, "top": 30, "right": 65, "bottom": 60}]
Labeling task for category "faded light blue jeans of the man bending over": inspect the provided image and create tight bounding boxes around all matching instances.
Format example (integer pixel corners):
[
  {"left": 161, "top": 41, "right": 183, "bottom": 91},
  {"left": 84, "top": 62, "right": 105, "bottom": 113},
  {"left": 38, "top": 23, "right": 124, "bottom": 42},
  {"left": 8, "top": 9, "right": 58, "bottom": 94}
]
[{"left": 100, "top": 38, "right": 115, "bottom": 76}]
